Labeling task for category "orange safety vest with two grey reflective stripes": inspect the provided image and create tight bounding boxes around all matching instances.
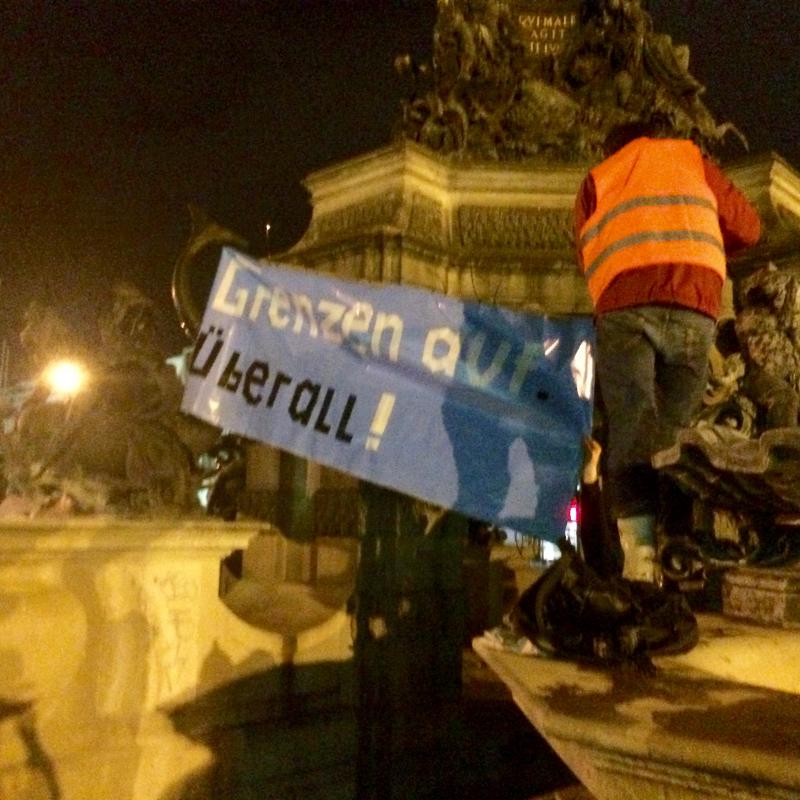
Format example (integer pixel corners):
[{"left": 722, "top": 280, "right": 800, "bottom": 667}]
[{"left": 580, "top": 138, "right": 725, "bottom": 305}]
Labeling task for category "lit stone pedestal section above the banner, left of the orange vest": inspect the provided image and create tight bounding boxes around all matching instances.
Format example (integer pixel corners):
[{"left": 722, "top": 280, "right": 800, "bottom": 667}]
[{"left": 282, "top": 141, "right": 591, "bottom": 315}]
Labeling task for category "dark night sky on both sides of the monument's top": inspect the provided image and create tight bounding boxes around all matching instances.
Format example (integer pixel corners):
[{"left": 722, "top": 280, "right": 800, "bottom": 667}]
[{"left": 0, "top": 0, "right": 800, "bottom": 378}]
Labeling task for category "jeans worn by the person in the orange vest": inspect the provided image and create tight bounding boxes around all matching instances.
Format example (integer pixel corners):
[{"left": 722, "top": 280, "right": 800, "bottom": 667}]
[{"left": 597, "top": 306, "right": 715, "bottom": 519}]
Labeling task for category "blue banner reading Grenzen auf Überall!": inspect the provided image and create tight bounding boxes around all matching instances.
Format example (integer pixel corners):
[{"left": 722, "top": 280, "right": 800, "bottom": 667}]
[{"left": 182, "top": 249, "right": 593, "bottom": 541}]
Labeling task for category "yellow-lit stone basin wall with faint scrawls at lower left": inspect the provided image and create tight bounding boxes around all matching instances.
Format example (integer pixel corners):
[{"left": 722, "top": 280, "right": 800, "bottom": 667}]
[{"left": 0, "top": 517, "right": 351, "bottom": 800}]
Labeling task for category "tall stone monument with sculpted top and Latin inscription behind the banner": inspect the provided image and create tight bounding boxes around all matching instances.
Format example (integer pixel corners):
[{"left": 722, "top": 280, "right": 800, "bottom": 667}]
[{"left": 170, "top": 0, "right": 800, "bottom": 636}]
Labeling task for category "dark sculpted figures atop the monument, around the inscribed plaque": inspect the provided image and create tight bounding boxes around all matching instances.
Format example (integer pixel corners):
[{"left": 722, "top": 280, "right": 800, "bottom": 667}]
[{"left": 395, "top": 0, "right": 746, "bottom": 163}]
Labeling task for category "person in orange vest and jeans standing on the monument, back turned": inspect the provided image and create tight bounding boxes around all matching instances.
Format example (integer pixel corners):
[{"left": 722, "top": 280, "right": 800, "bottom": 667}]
[{"left": 574, "top": 123, "right": 761, "bottom": 581}]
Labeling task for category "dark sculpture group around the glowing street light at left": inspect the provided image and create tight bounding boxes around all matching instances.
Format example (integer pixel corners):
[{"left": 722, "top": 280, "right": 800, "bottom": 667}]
[{"left": 0, "top": 283, "right": 218, "bottom": 513}]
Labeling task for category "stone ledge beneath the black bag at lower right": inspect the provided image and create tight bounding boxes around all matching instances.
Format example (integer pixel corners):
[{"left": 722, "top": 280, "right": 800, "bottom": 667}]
[{"left": 473, "top": 614, "right": 800, "bottom": 800}]
